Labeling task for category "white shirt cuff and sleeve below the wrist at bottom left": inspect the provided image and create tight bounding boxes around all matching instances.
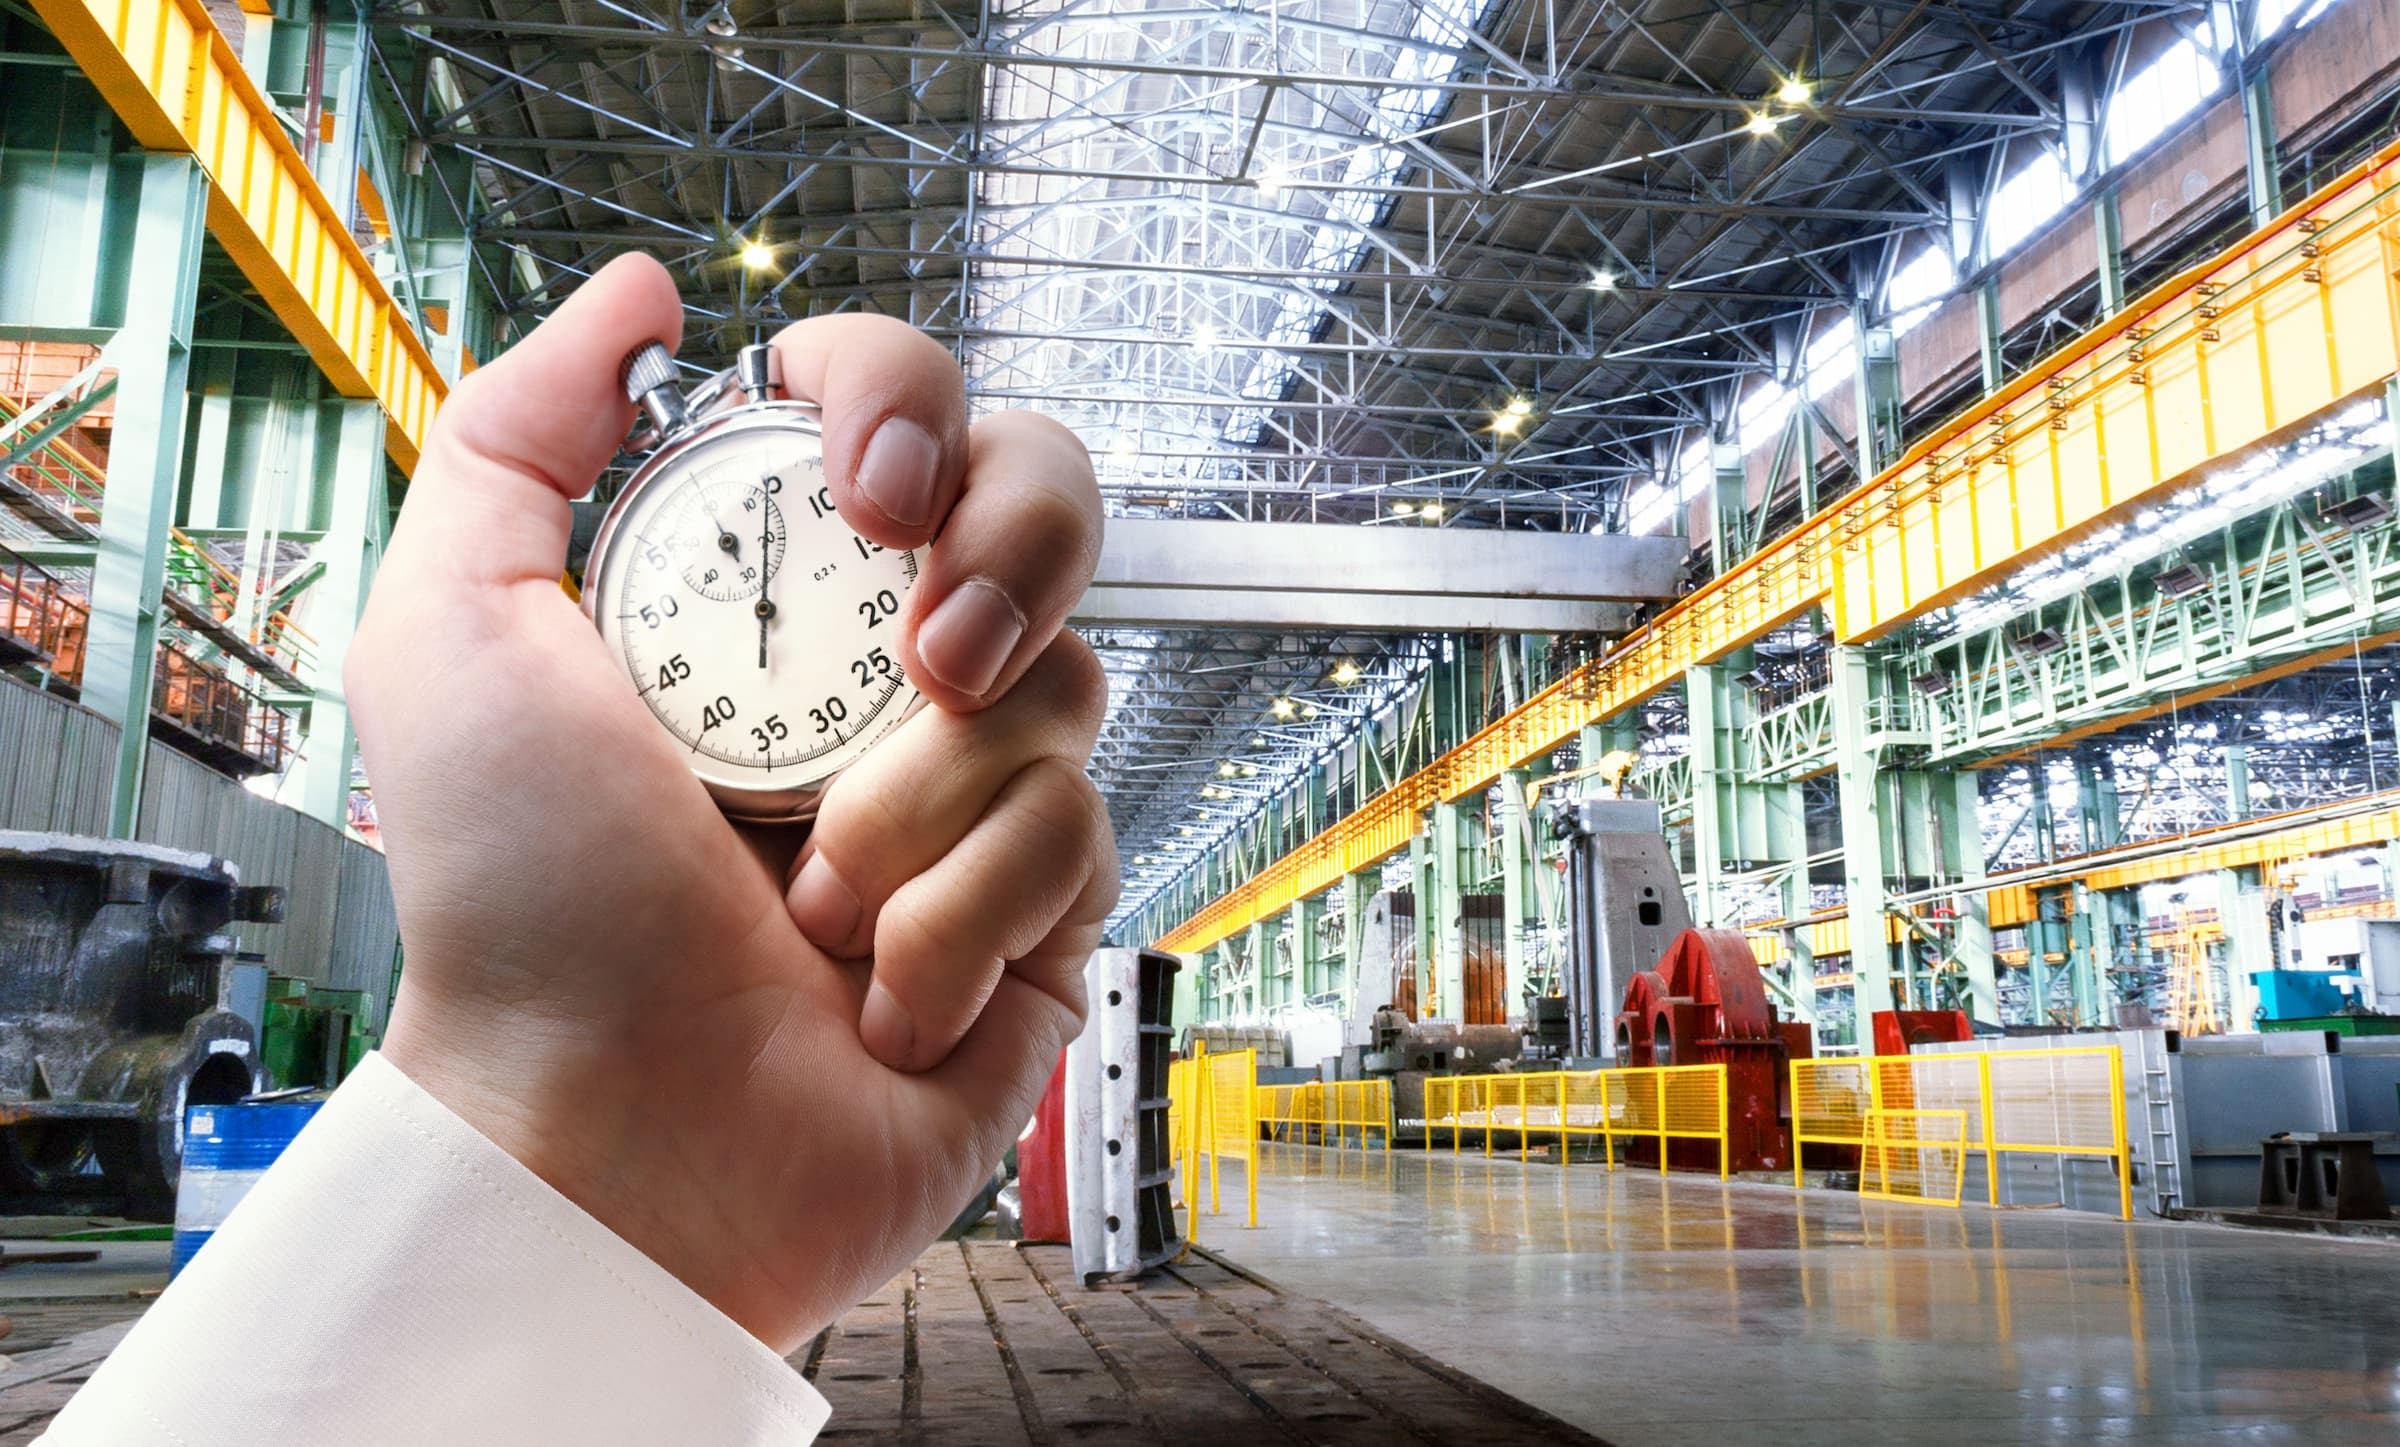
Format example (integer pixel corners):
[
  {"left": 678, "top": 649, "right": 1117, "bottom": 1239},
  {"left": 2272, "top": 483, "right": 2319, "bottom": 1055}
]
[{"left": 41, "top": 1056, "right": 826, "bottom": 1447}]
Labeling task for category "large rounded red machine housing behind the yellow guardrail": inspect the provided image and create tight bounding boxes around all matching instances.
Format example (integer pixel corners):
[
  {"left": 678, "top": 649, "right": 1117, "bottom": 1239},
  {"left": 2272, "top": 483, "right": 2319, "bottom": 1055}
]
[{"left": 1618, "top": 929, "right": 1814, "bottom": 1171}]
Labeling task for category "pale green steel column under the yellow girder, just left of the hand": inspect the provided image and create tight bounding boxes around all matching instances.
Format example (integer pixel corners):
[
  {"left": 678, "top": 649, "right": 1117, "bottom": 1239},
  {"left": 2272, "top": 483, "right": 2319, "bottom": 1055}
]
[{"left": 300, "top": 401, "right": 386, "bottom": 828}]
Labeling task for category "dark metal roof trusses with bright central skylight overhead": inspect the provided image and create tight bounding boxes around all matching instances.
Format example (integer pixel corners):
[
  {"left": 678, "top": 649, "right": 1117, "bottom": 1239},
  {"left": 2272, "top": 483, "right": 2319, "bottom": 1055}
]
[{"left": 377, "top": 0, "right": 2208, "bottom": 926}]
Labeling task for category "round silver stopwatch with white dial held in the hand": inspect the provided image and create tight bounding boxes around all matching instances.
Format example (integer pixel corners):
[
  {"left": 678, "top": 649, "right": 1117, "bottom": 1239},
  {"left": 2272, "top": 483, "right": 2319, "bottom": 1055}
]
[{"left": 583, "top": 341, "right": 919, "bottom": 823}]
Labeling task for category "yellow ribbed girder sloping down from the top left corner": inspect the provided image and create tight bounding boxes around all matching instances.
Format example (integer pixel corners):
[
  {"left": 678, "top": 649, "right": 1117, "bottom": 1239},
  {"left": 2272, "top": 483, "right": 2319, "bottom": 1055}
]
[{"left": 34, "top": 0, "right": 449, "bottom": 468}]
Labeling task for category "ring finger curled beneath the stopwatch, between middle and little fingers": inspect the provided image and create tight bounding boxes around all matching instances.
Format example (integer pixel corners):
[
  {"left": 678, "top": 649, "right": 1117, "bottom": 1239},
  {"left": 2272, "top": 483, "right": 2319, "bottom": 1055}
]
[{"left": 787, "top": 636, "right": 1109, "bottom": 957}]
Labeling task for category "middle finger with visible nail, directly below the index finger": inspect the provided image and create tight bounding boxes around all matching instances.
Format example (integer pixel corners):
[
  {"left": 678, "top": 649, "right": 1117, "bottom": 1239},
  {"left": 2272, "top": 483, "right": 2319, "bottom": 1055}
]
[{"left": 900, "top": 413, "right": 1102, "bottom": 713}]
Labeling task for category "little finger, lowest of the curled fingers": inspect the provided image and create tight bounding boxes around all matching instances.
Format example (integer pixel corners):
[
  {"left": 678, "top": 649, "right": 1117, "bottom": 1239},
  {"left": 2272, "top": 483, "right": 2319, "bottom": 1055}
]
[{"left": 859, "top": 758, "right": 1116, "bottom": 1070}]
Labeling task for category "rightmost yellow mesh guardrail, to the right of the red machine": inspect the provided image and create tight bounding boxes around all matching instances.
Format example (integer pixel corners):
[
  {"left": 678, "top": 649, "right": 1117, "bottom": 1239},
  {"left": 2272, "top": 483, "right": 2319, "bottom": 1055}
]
[{"left": 1790, "top": 1046, "right": 2134, "bottom": 1221}]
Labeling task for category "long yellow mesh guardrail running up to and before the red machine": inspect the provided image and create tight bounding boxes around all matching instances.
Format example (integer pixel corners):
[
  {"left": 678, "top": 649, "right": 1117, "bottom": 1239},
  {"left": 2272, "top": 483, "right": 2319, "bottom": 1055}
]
[{"left": 1426, "top": 1065, "right": 1733, "bottom": 1178}]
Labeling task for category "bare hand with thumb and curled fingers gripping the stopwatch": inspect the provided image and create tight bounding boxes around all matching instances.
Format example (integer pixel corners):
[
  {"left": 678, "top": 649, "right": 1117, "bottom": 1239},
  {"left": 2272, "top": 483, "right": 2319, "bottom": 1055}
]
[{"left": 346, "top": 257, "right": 1116, "bottom": 1351}]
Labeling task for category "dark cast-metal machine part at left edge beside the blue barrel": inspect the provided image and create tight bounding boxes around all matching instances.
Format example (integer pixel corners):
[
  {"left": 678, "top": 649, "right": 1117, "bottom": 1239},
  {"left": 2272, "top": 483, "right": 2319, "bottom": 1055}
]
[{"left": 0, "top": 830, "right": 283, "bottom": 1212}]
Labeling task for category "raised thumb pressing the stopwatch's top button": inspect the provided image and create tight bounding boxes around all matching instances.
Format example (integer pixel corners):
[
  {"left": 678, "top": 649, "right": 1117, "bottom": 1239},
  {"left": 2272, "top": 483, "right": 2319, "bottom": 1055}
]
[{"left": 386, "top": 252, "right": 684, "bottom": 583}]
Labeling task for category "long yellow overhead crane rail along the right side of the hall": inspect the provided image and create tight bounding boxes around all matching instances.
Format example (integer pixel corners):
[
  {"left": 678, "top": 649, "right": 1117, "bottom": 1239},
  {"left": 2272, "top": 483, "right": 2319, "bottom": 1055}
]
[{"left": 1159, "top": 142, "right": 2400, "bottom": 950}]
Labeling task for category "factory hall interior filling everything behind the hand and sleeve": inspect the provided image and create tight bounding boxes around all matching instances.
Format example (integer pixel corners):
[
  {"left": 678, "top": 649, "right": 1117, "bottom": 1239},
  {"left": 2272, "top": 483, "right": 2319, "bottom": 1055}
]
[{"left": 0, "top": 0, "right": 2400, "bottom": 1447}]
